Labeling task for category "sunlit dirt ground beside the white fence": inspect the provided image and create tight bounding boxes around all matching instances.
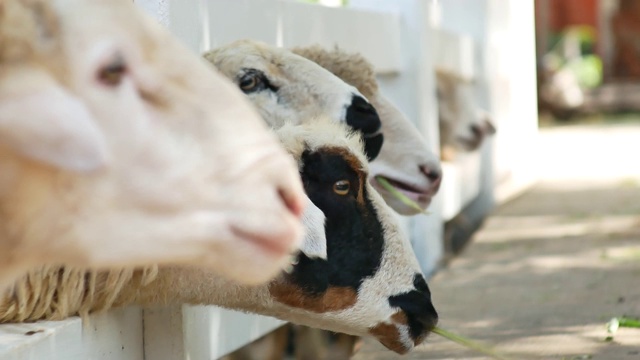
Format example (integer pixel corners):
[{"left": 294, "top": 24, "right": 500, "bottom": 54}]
[{"left": 354, "top": 119, "right": 640, "bottom": 360}]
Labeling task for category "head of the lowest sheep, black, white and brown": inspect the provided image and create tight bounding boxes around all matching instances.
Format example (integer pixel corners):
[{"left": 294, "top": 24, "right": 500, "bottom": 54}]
[{"left": 268, "top": 121, "right": 438, "bottom": 353}]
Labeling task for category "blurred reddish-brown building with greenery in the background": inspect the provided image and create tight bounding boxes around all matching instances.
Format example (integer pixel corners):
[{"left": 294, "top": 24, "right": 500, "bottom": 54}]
[{"left": 535, "top": 0, "right": 640, "bottom": 118}]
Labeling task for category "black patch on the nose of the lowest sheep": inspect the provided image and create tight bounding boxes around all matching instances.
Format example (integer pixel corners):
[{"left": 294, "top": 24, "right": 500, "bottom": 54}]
[{"left": 389, "top": 274, "right": 438, "bottom": 340}]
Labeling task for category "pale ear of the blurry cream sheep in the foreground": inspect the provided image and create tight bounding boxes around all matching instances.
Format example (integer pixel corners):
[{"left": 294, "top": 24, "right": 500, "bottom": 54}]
[{"left": 0, "top": 70, "right": 108, "bottom": 172}]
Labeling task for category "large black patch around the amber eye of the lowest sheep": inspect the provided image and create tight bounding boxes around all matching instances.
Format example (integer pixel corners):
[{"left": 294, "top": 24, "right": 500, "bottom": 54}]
[{"left": 286, "top": 150, "right": 384, "bottom": 296}]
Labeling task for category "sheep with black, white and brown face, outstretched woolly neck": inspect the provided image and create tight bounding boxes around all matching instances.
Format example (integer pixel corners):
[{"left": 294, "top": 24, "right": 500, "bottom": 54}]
[{"left": 0, "top": 119, "right": 438, "bottom": 353}]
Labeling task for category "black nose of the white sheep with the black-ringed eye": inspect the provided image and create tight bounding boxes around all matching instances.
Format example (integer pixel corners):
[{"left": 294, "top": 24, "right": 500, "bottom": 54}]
[{"left": 346, "top": 95, "right": 384, "bottom": 161}]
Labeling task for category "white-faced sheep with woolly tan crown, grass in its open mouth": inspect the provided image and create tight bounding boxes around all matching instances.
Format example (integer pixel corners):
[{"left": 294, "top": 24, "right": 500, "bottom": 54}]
[{"left": 291, "top": 46, "right": 442, "bottom": 215}]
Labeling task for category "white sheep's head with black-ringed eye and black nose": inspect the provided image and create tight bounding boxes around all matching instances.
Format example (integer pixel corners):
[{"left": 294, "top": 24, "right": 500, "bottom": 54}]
[{"left": 204, "top": 40, "right": 383, "bottom": 160}]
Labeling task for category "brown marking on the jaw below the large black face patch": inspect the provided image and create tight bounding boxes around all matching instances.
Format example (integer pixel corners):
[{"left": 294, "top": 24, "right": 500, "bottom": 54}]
[{"left": 269, "top": 281, "right": 358, "bottom": 313}]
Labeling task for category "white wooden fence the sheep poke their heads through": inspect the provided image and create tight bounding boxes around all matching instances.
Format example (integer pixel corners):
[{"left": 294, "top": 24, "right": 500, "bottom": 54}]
[{"left": 0, "top": 0, "right": 537, "bottom": 360}]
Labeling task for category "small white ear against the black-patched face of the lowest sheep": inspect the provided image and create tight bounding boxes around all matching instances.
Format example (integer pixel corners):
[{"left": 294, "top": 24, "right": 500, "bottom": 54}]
[{"left": 300, "top": 198, "right": 327, "bottom": 260}]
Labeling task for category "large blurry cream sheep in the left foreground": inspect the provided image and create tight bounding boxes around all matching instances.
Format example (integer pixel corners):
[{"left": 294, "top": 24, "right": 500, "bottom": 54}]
[{"left": 0, "top": 0, "right": 305, "bottom": 289}]
